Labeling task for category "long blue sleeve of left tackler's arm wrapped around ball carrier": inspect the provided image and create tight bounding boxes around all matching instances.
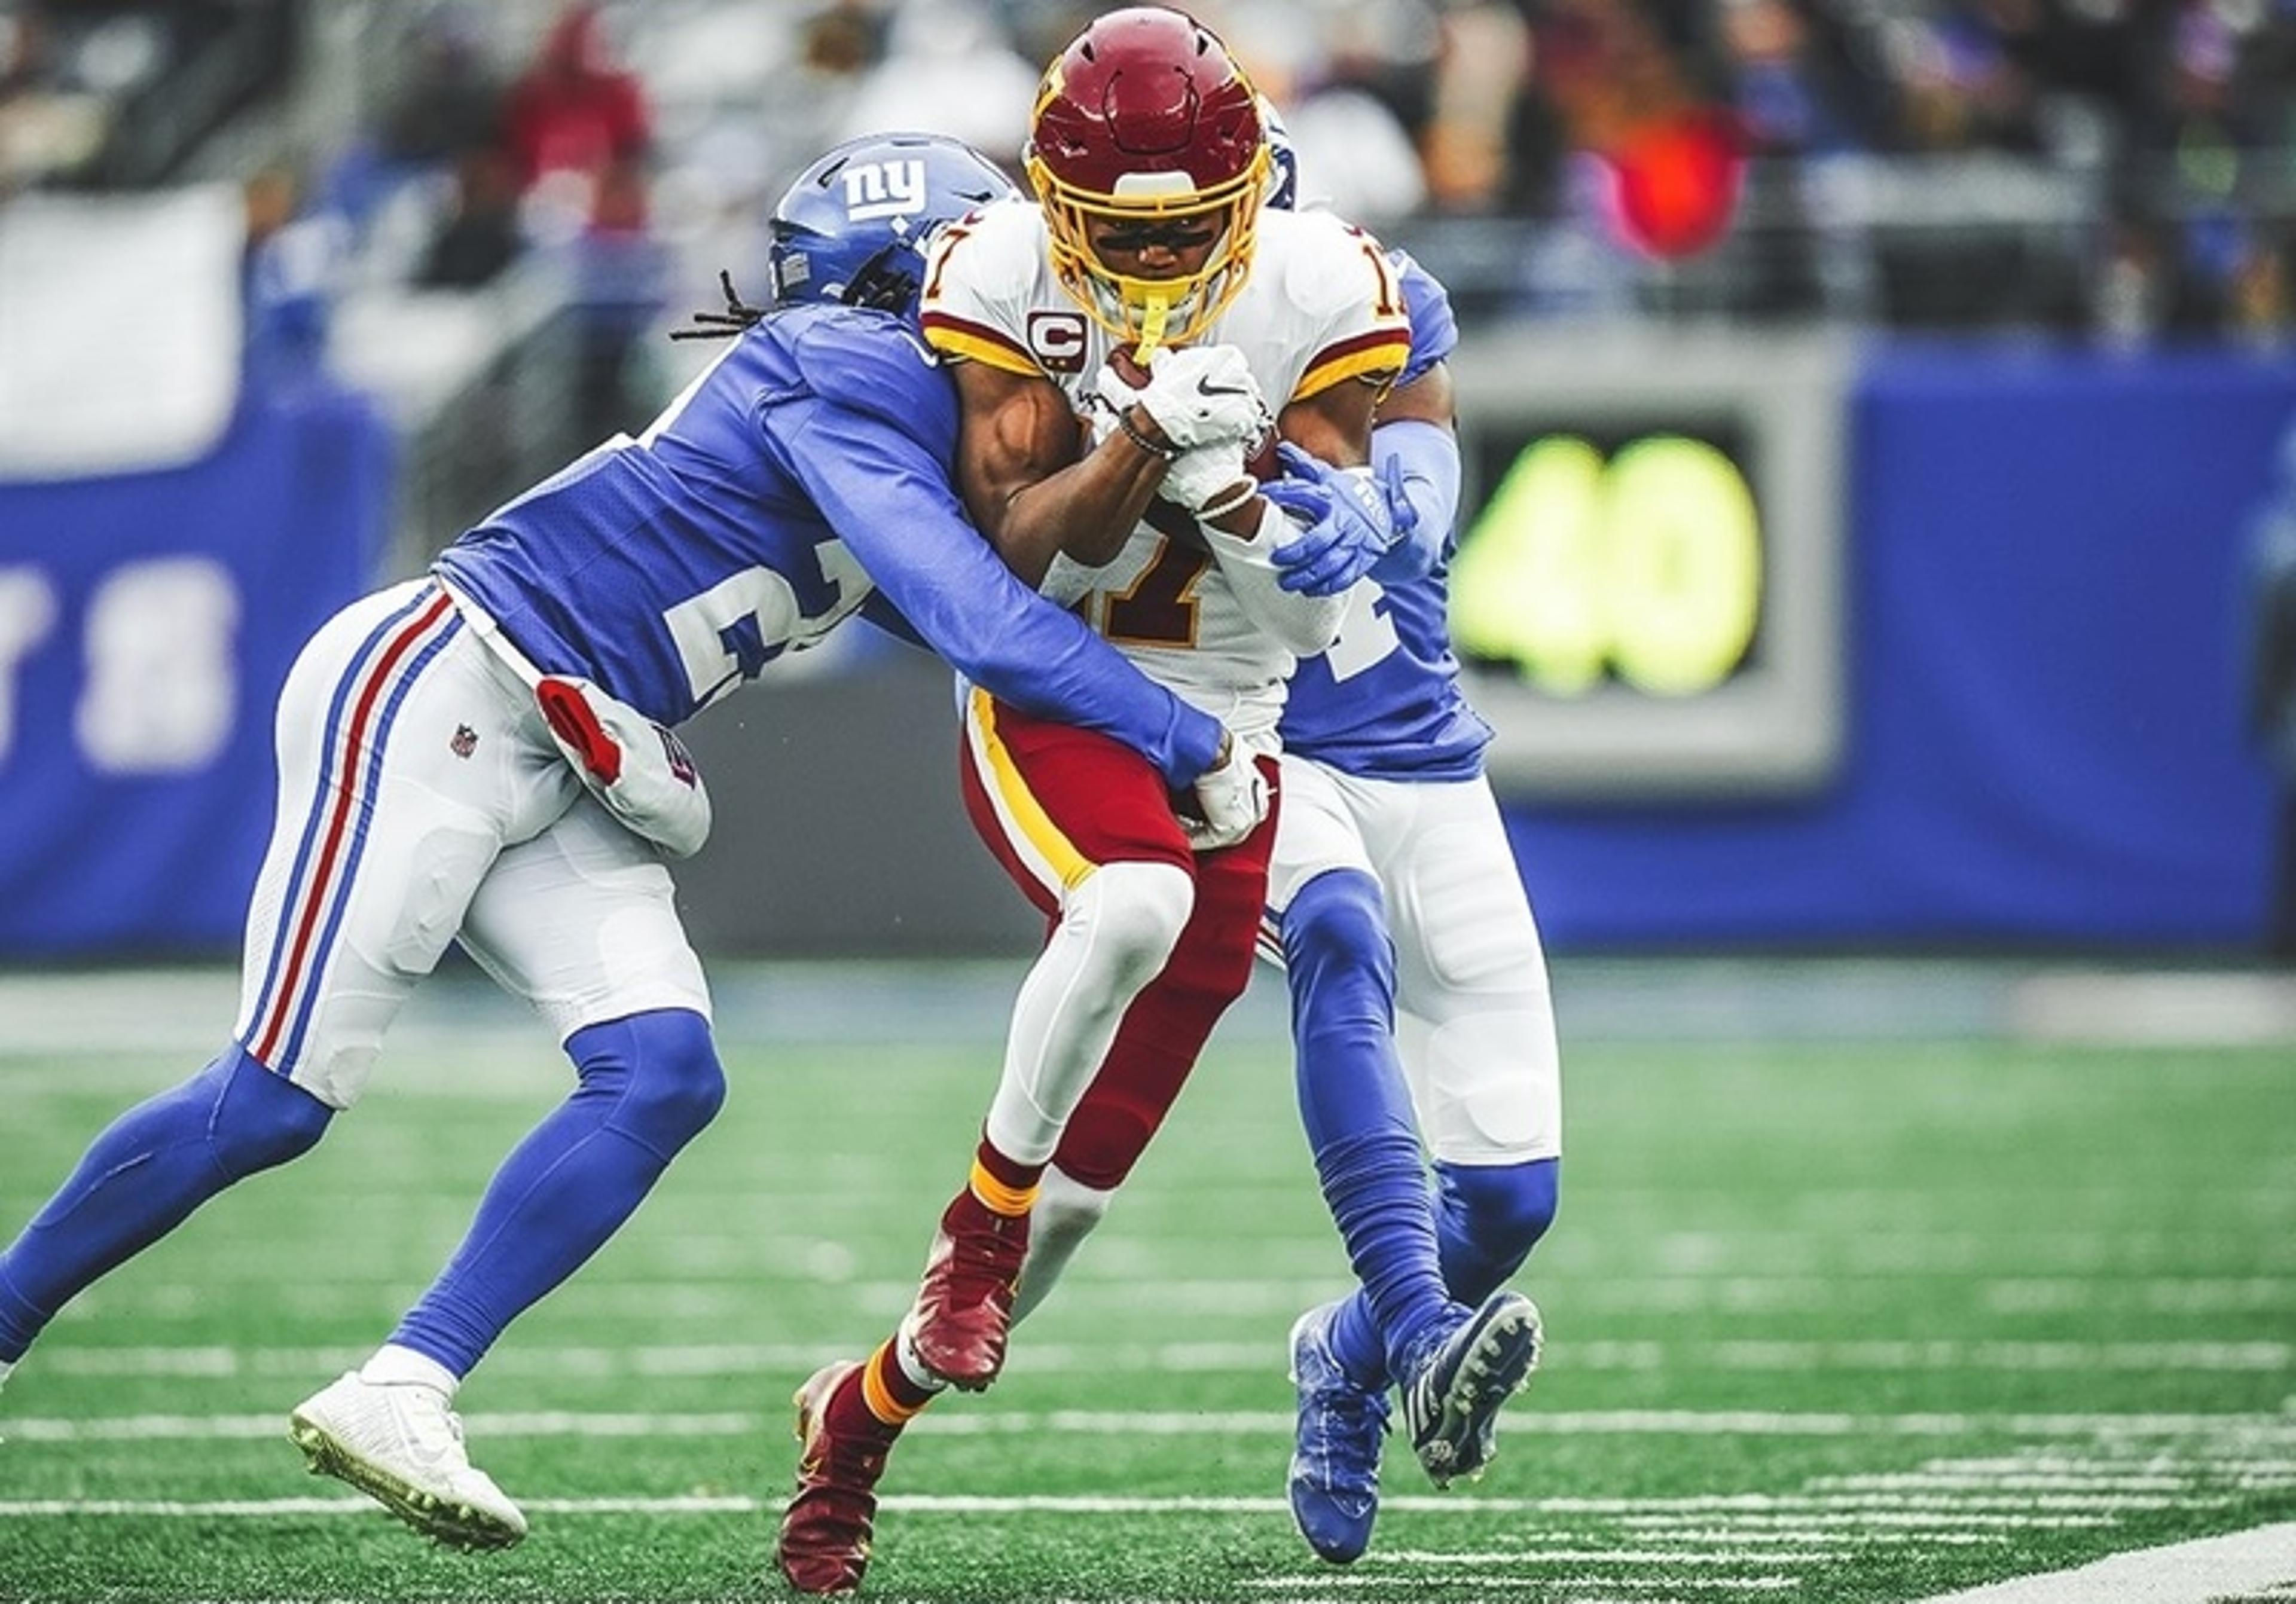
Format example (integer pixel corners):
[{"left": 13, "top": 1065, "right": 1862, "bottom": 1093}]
[{"left": 769, "top": 397, "right": 1222, "bottom": 787}]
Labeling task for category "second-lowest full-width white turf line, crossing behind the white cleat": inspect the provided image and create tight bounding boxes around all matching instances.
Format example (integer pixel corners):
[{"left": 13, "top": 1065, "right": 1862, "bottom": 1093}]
[{"left": 13, "top": 1409, "right": 2296, "bottom": 1450}]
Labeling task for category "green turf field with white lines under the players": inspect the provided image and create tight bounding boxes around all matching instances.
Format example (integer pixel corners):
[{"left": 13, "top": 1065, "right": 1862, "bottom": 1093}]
[{"left": 0, "top": 971, "right": 2296, "bottom": 1604}]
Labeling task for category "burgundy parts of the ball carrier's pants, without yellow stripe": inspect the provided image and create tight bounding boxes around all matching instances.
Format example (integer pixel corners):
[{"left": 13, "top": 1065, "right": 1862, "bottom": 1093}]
[{"left": 962, "top": 702, "right": 1281, "bottom": 1189}]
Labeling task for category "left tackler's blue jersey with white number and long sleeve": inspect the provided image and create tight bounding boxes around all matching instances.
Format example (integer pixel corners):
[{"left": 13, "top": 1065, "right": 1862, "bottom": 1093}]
[{"left": 434, "top": 305, "right": 1222, "bottom": 785}]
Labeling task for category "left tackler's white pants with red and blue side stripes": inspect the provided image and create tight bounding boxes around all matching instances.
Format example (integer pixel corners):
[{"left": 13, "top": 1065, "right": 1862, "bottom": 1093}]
[{"left": 237, "top": 581, "right": 710, "bottom": 1108}]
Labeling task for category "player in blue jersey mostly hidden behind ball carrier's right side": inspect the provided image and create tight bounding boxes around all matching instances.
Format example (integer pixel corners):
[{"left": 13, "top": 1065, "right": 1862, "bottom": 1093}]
[{"left": 1263, "top": 124, "right": 1561, "bottom": 1563}]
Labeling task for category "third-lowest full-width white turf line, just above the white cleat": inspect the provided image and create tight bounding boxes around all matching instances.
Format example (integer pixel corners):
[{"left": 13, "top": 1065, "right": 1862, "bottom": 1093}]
[{"left": 27, "top": 1340, "right": 2296, "bottom": 1379}]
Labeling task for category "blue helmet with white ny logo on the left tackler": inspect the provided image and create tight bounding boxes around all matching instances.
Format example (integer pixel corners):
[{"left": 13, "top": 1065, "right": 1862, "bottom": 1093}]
[{"left": 769, "top": 133, "right": 1019, "bottom": 312}]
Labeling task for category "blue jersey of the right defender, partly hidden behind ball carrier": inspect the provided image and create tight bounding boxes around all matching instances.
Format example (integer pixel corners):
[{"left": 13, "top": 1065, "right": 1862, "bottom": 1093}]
[{"left": 1284, "top": 250, "right": 1490, "bottom": 780}]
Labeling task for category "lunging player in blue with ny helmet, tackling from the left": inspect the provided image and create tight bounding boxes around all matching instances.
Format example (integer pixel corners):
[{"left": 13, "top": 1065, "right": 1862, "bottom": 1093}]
[{"left": 0, "top": 135, "right": 1268, "bottom": 1549}]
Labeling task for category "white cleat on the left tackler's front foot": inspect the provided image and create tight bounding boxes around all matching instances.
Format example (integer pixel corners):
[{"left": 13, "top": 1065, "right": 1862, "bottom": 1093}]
[{"left": 287, "top": 1370, "right": 526, "bottom": 1549}]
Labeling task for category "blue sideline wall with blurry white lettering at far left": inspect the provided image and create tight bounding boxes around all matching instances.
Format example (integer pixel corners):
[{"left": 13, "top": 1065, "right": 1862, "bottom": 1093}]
[{"left": 0, "top": 386, "right": 393, "bottom": 959}]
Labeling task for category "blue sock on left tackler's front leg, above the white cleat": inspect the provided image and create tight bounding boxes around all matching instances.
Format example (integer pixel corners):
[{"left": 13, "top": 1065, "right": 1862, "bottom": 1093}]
[{"left": 390, "top": 1007, "right": 725, "bottom": 1377}]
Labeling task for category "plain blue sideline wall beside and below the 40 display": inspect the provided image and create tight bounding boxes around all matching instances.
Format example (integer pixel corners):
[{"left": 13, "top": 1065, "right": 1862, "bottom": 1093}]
[{"left": 1509, "top": 349, "right": 2296, "bottom": 950}]
